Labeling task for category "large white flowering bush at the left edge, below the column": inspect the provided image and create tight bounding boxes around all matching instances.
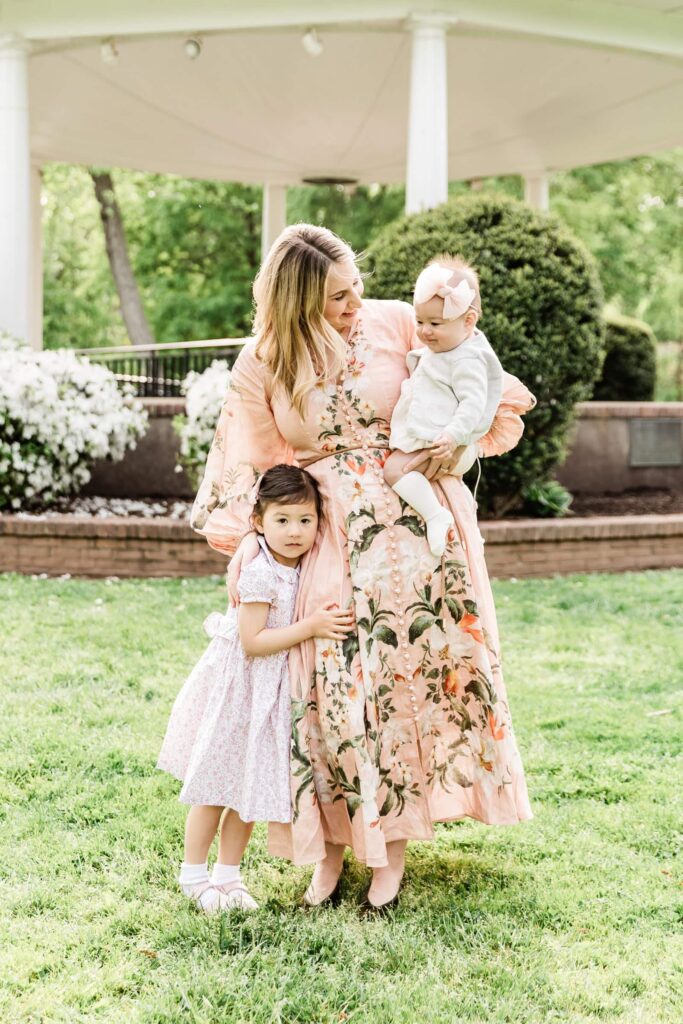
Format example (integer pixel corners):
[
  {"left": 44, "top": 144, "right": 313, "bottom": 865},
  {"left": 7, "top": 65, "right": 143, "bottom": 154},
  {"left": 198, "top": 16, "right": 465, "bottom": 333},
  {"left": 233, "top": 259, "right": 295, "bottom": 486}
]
[{"left": 0, "top": 335, "right": 147, "bottom": 511}]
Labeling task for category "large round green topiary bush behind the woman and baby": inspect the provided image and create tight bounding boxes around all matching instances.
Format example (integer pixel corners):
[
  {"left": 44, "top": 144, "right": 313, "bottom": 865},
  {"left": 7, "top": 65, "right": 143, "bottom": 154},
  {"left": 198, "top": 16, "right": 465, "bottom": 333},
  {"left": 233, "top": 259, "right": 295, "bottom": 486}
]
[{"left": 367, "top": 193, "right": 604, "bottom": 516}]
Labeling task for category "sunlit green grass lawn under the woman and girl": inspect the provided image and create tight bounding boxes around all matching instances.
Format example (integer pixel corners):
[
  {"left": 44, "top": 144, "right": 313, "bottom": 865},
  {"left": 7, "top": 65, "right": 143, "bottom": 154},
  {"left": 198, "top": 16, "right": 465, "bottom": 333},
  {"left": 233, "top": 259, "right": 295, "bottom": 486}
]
[{"left": 0, "top": 571, "right": 683, "bottom": 1024}]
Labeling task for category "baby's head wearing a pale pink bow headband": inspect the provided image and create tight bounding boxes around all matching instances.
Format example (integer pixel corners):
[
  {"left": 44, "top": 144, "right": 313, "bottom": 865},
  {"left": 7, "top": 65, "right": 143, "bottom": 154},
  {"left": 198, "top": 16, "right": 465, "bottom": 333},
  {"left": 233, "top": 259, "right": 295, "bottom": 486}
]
[{"left": 413, "top": 254, "right": 481, "bottom": 352}]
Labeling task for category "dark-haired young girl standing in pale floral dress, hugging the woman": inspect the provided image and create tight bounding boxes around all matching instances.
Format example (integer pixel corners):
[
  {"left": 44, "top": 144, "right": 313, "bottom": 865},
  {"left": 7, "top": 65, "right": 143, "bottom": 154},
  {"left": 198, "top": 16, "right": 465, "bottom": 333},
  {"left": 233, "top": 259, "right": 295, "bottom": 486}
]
[{"left": 158, "top": 466, "right": 352, "bottom": 912}]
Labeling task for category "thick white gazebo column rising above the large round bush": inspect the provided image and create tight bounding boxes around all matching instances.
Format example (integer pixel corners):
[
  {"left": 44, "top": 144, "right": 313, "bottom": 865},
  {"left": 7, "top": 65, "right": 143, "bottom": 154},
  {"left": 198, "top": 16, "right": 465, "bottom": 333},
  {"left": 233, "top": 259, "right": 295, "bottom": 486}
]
[{"left": 405, "top": 15, "right": 449, "bottom": 213}]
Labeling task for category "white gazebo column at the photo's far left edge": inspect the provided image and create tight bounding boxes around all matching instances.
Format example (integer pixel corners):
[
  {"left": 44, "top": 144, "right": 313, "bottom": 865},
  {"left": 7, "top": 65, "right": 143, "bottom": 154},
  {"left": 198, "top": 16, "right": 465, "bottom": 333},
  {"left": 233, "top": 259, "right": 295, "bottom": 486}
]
[{"left": 0, "top": 36, "right": 33, "bottom": 339}]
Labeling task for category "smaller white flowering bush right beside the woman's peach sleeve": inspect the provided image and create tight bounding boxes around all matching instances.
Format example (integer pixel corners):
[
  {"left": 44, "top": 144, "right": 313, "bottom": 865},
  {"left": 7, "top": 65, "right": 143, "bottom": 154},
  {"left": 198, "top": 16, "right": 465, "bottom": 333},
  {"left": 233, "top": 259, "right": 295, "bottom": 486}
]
[{"left": 173, "top": 359, "right": 230, "bottom": 487}]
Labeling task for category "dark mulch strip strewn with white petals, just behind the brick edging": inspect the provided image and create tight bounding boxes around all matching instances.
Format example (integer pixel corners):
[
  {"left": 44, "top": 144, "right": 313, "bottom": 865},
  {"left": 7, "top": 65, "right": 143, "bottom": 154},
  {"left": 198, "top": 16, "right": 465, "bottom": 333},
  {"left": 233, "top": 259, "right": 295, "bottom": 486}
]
[{"left": 10, "top": 490, "right": 683, "bottom": 519}]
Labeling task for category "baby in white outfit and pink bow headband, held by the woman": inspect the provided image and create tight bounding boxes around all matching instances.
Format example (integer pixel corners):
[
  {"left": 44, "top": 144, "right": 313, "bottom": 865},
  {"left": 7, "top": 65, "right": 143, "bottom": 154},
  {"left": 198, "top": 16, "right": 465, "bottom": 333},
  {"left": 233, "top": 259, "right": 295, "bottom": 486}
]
[{"left": 384, "top": 256, "right": 503, "bottom": 557}]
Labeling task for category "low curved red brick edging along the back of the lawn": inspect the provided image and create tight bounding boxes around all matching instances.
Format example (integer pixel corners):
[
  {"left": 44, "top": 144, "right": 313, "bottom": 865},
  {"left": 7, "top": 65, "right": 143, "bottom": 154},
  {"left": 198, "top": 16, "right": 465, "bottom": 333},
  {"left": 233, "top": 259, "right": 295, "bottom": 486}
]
[{"left": 0, "top": 514, "right": 683, "bottom": 578}]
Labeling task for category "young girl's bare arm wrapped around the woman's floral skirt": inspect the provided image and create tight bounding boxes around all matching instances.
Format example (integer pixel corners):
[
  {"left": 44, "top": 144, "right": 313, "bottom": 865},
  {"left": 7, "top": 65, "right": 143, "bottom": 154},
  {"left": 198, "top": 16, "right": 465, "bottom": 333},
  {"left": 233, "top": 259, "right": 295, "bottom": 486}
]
[{"left": 238, "top": 601, "right": 353, "bottom": 657}]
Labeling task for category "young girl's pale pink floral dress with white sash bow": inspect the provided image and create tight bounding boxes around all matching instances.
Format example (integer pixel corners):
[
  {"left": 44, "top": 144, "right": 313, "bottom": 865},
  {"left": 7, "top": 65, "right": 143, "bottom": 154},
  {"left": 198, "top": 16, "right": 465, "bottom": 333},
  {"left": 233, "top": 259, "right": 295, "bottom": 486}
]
[{"left": 157, "top": 543, "right": 299, "bottom": 822}]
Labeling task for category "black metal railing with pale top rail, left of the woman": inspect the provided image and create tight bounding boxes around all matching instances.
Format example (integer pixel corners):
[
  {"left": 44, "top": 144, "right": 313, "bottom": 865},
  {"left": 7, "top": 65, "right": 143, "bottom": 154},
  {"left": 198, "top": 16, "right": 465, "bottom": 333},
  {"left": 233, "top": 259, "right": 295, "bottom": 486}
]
[{"left": 79, "top": 338, "right": 246, "bottom": 398}]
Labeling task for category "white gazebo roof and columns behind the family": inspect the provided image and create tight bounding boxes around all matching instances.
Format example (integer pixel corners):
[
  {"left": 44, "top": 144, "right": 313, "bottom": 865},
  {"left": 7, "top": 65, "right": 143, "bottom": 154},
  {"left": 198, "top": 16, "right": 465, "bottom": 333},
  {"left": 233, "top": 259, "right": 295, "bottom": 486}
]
[{"left": 0, "top": 0, "right": 683, "bottom": 345}]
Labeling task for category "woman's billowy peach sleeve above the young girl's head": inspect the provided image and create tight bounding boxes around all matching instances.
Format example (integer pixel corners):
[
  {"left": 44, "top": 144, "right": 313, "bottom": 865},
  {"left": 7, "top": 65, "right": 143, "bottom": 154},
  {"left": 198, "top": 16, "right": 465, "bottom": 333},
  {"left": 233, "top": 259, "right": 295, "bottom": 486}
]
[{"left": 189, "top": 342, "right": 294, "bottom": 555}]
